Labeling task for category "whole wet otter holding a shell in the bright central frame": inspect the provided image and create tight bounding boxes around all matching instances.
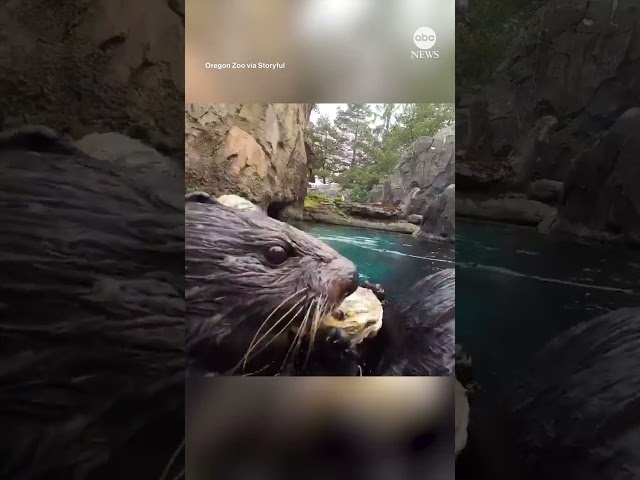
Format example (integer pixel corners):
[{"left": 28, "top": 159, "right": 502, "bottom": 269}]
[{"left": 185, "top": 192, "right": 455, "bottom": 376}]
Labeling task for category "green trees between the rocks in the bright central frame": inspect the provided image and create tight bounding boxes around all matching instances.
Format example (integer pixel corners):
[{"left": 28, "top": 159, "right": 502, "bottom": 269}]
[{"left": 307, "top": 103, "right": 454, "bottom": 201}]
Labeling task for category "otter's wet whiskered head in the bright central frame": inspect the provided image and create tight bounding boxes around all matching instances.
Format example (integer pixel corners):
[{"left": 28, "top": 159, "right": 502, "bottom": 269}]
[{"left": 185, "top": 202, "right": 358, "bottom": 374}]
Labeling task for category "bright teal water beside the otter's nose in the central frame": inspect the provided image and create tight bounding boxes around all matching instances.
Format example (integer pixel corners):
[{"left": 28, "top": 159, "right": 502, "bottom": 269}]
[{"left": 296, "top": 223, "right": 455, "bottom": 296}]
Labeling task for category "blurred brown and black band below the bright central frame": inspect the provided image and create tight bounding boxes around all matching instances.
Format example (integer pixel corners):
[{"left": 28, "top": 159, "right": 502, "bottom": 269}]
[{"left": 186, "top": 377, "right": 455, "bottom": 480}]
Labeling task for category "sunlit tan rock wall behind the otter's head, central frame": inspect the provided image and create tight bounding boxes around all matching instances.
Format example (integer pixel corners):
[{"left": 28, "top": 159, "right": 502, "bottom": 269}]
[{"left": 185, "top": 104, "right": 312, "bottom": 219}]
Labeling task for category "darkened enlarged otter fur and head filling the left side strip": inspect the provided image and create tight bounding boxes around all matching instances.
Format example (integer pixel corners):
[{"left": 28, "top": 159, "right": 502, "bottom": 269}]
[{"left": 0, "top": 127, "right": 185, "bottom": 480}]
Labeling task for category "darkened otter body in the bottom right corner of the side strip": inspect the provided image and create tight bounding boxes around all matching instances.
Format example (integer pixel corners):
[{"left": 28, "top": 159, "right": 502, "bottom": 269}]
[{"left": 461, "top": 308, "right": 640, "bottom": 480}]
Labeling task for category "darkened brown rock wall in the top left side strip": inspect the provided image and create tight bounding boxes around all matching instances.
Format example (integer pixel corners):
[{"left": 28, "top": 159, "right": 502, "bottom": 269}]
[{"left": 0, "top": 0, "right": 184, "bottom": 159}]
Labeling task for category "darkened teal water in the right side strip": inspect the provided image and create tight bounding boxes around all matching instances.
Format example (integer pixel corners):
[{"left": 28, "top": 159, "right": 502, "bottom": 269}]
[{"left": 456, "top": 220, "right": 640, "bottom": 382}]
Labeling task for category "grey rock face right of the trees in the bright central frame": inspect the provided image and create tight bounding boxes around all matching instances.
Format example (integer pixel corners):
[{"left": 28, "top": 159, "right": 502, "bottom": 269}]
[{"left": 370, "top": 126, "right": 455, "bottom": 215}]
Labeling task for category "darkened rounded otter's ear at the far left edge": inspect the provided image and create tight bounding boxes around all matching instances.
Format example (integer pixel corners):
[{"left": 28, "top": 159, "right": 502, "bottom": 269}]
[{"left": 0, "top": 125, "right": 81, "bottom": 155}]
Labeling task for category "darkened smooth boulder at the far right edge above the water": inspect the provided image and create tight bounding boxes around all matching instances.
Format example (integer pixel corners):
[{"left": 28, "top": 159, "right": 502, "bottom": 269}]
[{"left": 551, "top": 108, "right": 640, "bottom": 244}]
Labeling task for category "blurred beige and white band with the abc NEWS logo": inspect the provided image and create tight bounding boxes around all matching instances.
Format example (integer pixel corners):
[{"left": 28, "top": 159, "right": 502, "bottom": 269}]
[{"left": 185, "top": 0, "right": 455, "bottom": 103}]
